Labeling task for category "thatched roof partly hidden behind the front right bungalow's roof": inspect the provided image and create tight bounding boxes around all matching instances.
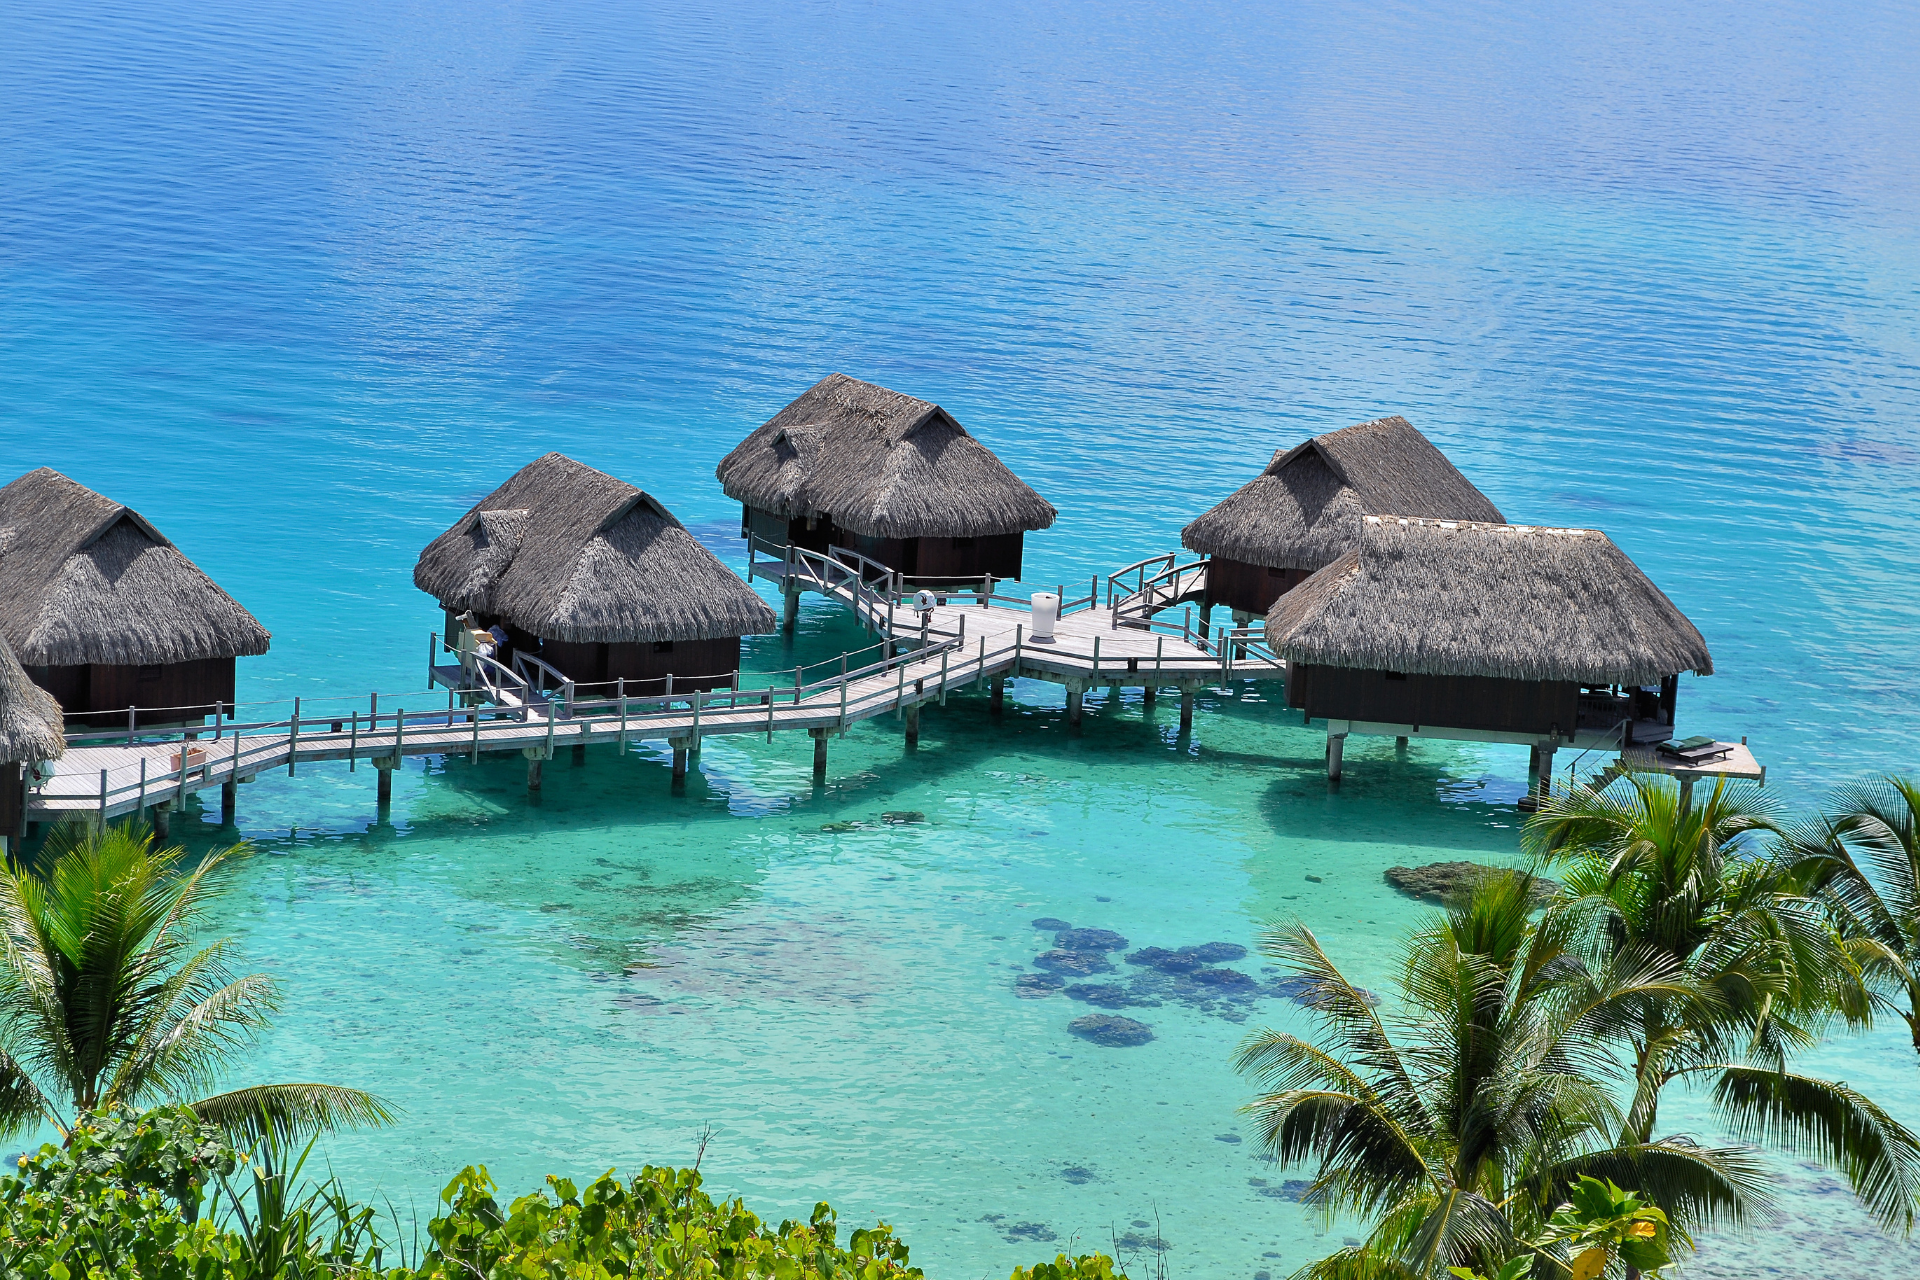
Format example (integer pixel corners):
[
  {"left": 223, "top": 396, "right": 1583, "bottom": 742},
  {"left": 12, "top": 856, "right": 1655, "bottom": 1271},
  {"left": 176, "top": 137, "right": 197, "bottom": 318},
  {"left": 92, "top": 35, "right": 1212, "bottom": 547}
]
[{"left": 1181, "top": 416, "right": 1505, "bottom": 570}]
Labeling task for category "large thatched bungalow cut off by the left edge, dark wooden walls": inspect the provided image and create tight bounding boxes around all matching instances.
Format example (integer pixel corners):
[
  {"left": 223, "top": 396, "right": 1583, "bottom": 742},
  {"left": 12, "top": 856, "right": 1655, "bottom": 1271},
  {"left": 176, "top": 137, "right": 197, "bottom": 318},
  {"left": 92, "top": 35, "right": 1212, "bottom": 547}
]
[{"left": 0, "top": 466, "right": 271, "bottom": 727}]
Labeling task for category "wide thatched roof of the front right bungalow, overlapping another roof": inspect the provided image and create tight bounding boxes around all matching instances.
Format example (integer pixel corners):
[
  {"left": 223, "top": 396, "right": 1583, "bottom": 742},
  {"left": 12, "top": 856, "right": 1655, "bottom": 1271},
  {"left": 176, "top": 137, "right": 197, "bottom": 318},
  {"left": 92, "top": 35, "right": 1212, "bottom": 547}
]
[{"left": 1267, "top": 516, "right": 1713, "bottom": 685}]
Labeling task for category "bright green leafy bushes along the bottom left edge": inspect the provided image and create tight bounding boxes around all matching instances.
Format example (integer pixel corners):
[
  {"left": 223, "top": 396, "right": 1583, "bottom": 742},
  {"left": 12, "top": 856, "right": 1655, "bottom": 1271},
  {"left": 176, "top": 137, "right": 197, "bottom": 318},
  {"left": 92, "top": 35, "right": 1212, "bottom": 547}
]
[{"left": 0, "top": 1105, "right": 1125, "bottom": 1280}]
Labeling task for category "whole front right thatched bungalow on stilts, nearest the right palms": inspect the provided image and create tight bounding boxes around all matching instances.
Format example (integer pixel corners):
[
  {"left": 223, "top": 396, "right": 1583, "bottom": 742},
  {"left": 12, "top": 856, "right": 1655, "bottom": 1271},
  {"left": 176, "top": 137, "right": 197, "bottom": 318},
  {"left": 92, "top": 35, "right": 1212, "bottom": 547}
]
[{"left": 1267, "top": 516, "right": 1713, "bottom": 794}]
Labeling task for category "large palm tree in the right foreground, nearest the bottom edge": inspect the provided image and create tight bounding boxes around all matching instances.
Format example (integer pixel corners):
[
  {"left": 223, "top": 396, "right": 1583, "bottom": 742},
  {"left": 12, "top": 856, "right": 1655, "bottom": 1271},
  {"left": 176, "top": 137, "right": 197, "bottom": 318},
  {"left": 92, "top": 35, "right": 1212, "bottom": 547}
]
[{"left": 1236, "top": 875, "right": 1764, "bottom": 1280}]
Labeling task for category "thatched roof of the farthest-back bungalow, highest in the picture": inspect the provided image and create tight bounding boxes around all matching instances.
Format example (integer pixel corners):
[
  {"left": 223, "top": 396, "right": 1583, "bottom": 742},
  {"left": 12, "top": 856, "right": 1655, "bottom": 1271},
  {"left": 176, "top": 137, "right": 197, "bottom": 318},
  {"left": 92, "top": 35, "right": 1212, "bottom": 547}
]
[{"left": 714, "top": 374, "right": 1058, "bottom": 537}]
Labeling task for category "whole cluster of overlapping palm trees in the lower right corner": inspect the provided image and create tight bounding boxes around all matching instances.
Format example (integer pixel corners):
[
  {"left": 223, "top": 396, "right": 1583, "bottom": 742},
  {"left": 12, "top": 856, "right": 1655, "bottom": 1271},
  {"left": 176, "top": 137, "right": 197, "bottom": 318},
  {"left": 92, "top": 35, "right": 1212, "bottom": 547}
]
[{"left": 1238, "top": 775, "right": 1920, "bottom": 1280}]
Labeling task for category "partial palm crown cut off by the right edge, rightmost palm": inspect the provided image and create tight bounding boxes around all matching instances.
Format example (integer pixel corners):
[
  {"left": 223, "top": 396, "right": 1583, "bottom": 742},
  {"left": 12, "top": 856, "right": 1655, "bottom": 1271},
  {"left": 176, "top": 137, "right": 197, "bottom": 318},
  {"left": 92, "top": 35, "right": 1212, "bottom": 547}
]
[{"left": 1784, "top": 775, "right": 1920, "bottom": 1052}]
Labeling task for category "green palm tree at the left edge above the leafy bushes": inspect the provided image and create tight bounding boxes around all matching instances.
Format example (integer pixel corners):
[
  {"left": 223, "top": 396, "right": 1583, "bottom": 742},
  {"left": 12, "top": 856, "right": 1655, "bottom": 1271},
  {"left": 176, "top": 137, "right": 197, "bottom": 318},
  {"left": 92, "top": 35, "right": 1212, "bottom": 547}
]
[{"left": 0, "top": 825, "right": 394, "bottom": 1140}]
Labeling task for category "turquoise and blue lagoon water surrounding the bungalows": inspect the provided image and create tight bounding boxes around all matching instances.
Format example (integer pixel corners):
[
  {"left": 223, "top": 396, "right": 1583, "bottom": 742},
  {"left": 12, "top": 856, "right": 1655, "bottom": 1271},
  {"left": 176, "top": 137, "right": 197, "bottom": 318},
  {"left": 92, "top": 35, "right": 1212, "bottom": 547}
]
[{"left": 0, "top": 0, "right": 1920, "bottom": 1278}]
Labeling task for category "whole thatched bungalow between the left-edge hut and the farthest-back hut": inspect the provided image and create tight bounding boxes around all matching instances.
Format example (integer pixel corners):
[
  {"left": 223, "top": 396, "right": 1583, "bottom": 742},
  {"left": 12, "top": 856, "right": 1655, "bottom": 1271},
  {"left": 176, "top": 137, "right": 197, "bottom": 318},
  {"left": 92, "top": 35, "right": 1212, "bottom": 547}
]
[{"left": 413, "top": 453, "right": 778, "bottom": 695}]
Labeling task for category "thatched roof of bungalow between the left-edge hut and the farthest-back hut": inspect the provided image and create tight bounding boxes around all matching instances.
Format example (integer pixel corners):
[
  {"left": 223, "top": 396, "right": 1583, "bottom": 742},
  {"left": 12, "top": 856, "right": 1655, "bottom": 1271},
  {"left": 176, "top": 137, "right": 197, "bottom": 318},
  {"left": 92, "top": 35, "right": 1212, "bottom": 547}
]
[{"left": 413, "top": 453, "right": 778, "bottom": 645}]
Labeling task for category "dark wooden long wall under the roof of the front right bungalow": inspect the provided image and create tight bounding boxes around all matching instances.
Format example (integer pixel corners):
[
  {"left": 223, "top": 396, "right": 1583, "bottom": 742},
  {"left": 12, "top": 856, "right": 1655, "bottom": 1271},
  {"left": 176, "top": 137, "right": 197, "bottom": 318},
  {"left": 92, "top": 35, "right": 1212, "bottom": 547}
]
[{"left": 1286, "top": 662, "right": 1580, "bottom": 739}]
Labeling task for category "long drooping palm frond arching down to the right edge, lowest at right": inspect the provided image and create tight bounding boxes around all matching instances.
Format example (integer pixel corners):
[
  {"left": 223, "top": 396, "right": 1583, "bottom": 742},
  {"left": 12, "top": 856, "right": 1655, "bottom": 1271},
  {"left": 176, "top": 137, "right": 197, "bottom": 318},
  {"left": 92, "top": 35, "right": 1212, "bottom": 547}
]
[{"left": 1713, "top": 1065, "right": 1920, "bottom": 1234}]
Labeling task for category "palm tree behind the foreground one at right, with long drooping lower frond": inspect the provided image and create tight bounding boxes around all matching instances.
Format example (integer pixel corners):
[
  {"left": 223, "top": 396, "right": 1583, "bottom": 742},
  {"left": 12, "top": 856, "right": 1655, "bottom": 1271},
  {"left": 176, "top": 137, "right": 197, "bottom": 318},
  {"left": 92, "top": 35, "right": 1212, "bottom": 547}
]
[{"left": 1524, "top": 773, "right": 1920, "bottom": 1230}]
